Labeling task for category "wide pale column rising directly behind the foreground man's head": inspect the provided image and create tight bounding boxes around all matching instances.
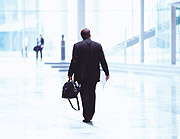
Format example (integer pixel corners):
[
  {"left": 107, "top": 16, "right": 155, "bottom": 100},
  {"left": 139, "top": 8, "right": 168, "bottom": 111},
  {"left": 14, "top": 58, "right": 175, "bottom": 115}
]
[{"left": 77, "top": 0, "right": 85, "bottom": 41}]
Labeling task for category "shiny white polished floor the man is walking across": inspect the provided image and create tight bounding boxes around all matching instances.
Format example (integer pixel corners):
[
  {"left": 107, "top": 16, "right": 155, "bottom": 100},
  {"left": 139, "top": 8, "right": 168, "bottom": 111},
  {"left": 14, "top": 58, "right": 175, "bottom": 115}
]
[{"left": 0, "top": 58, "right": 180, "bottom": 139}]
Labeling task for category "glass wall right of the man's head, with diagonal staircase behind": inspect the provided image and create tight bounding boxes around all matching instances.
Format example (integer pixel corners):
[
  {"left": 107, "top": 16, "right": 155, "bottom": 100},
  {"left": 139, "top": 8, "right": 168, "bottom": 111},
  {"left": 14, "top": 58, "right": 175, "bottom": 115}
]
[{"left": 86, "top": 0, "right": 179, "bottom": 64}]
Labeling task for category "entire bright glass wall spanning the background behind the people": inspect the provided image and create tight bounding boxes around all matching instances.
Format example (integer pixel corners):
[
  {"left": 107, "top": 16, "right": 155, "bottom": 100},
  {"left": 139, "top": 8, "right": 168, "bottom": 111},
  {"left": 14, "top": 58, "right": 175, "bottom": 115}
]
[{"left": 0, "top": 0, "right": 180, "bottom": 64}]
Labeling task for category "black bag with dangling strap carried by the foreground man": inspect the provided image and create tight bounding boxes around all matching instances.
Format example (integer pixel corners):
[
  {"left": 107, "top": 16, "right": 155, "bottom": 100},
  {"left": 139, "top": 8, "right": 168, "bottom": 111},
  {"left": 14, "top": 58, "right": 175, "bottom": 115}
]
[{"left": 62, "top": 80, "right": 81, "bottom": 110}]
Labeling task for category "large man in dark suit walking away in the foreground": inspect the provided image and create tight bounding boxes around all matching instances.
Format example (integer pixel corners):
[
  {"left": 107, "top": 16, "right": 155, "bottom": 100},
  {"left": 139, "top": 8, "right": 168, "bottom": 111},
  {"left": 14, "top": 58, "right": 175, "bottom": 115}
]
[{"left": 68, "top": 28, "right": 109, "bottom": 123}]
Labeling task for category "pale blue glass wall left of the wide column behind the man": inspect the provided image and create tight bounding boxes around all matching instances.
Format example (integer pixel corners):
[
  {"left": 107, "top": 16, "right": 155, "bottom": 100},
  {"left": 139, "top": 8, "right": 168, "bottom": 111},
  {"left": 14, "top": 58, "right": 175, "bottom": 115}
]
[{"left": 0, "top": 0, "right": 77, "bottom": 59}]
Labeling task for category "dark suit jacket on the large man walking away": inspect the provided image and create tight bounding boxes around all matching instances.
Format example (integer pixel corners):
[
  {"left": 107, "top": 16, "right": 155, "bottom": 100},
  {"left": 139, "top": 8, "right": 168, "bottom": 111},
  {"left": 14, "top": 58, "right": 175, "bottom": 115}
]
[{"left": 68, "top": 39, "right": 109, "bottom": 82}]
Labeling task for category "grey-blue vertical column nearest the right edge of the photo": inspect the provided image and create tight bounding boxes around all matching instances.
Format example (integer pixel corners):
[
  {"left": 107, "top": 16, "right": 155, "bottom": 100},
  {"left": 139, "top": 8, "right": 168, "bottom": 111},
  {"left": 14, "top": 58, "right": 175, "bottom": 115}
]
[{"left": 170, "top": 5, "right": 176, "bottom": 64}]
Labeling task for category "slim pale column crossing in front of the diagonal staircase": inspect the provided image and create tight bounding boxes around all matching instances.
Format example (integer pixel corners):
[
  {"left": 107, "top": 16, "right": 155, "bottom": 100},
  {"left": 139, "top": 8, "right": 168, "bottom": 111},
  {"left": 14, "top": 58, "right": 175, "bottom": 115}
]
[{"left": 139, "top": 0, "right": 144, "bottom": 63}]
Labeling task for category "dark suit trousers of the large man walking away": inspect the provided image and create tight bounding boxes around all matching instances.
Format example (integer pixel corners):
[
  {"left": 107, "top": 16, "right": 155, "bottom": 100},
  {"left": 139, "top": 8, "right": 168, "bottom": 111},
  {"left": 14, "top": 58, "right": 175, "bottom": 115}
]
[{"left": 80, "top": 81, "right": 97, "bottom": 120}]
